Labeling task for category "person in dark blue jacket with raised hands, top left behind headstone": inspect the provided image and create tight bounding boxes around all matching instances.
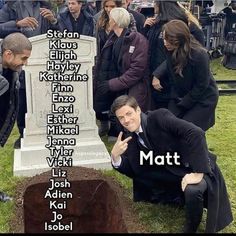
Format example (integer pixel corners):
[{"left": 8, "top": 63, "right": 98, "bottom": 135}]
[{"left": 0, "top": 0, "right": 57, "bottom": 149}]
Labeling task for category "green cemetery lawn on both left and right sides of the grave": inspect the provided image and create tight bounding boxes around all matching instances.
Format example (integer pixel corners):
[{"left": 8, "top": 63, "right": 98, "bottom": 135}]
[{"left": 0, "top": 59, "right": 236, "bottom": 233}]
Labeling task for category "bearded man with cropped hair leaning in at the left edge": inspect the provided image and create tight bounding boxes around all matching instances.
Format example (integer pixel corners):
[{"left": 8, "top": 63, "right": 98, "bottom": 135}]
[{"left": 0, "top": 33, "right": 32, "bottom": 201}]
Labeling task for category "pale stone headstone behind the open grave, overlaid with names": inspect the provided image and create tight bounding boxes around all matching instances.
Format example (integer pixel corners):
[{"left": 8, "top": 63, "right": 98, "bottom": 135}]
[{"left": 14, "top": 34, "right": 111, "bottom": 176}]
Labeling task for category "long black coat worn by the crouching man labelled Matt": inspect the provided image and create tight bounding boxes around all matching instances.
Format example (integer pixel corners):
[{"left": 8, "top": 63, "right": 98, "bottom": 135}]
[{"left": 115, "top": 109, "right": 233, "bottom": 232}]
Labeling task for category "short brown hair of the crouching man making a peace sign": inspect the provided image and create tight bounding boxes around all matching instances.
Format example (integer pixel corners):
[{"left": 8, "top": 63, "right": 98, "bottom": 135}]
[{"left": 111, "top": 95, "right": 138, "bottom": 114}]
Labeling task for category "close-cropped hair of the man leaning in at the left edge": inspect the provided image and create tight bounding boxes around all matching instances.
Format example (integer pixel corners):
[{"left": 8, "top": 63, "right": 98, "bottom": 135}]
[{"left": 2, "top": 33, "right": 32, "bottom": 54}]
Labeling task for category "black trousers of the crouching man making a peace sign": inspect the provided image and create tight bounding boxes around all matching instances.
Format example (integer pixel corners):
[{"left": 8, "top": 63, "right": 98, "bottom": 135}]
[{"left": 133, "top": 174, "right": 207, "bottom": 233}]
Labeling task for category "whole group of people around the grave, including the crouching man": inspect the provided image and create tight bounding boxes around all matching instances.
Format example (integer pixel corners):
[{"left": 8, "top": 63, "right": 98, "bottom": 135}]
[{"left": 0, "top": 0, "right": 235, "bottom": 233}]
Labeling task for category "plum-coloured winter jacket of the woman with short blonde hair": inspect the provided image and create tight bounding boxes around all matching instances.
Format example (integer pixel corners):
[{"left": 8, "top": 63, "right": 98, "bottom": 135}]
[{"left": 109, "top": 30, "right": 150, "bottom": 111}]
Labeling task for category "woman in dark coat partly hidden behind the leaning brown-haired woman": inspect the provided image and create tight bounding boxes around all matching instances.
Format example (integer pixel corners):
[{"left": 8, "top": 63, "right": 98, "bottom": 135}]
[{"left": 143, "top": 0, "right": 204, "bottom": 109}]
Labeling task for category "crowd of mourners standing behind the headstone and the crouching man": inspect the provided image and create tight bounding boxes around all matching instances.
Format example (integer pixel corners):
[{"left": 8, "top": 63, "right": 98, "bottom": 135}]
[{"left": 0, "top": 0, "right": 234, "bottom": 142}]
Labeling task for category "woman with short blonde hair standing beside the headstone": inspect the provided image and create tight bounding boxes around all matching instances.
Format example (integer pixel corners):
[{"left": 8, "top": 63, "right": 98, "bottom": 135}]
[{"left": 94, "top": 7, "right": 150, "bottom": 137}]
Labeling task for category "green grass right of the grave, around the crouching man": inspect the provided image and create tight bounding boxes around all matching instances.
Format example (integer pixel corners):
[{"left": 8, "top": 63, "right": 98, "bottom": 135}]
[{"left": 103, "top": 58, "right": 236, "bottom": 233}]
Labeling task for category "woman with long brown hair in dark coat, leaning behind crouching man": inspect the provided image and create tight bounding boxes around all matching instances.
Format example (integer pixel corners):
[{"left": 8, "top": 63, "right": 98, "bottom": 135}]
[{"left": 152, "top": 20, "right": 219, "bottom": 131}]
